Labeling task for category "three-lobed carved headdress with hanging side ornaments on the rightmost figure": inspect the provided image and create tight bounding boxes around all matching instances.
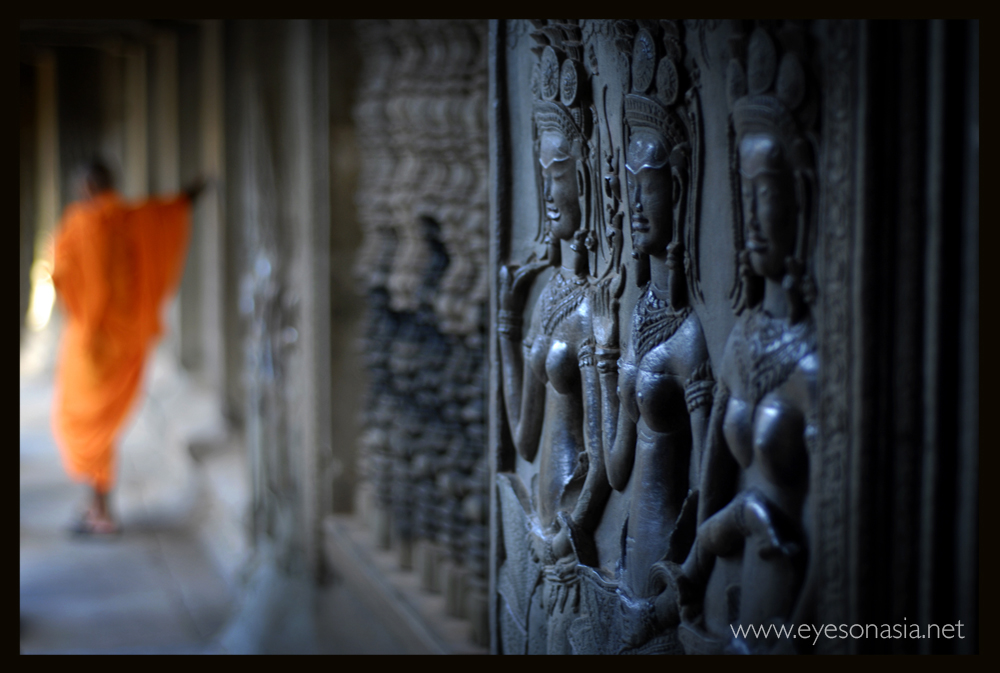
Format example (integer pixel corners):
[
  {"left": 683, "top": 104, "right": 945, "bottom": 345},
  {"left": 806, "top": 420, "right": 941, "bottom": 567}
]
[{"left": 726, "top": 25, "right": 816, "bottom": 320}]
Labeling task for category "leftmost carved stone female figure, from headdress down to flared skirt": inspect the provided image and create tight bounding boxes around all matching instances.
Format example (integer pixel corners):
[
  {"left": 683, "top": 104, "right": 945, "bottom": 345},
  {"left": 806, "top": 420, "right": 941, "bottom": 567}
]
[{"left": 497, "top": 20, "right": 611, "bottom": 653}]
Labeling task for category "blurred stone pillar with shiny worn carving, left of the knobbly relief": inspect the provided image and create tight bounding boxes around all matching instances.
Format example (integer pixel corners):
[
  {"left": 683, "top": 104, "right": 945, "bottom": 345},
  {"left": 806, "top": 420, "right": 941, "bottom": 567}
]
[{"left": 216, "top": 21, "right": 330, "bottom": 651}]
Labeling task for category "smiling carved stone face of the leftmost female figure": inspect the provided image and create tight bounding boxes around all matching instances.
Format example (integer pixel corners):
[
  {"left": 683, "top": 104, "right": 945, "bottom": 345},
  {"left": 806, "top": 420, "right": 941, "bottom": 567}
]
[{"left": 538, "top": 130, "right": 580, "bottom": 240}]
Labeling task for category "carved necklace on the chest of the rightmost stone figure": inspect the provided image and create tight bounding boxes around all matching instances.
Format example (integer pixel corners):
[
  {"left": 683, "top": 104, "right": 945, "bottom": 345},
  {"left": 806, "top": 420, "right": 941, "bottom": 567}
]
[{"left": 734, "top": 309, "right": 816, "bottom": 405}]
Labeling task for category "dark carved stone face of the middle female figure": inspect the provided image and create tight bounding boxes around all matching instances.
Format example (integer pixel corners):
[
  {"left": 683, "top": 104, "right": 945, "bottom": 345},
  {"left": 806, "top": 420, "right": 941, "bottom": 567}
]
[{"left": 625, "top": 132, "right": 674, "bottom": 255}]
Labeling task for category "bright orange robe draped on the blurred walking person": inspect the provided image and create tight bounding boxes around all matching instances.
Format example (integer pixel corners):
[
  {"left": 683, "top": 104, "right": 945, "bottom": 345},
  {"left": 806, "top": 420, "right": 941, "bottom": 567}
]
[{"left": 52, "top": 192, "right": 190, "bottom": 493}]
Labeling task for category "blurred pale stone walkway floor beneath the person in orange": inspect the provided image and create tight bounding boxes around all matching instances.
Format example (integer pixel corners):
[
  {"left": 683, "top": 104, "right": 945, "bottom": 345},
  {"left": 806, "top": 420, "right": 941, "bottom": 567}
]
[{"left": 20, "top": 325, "right": 232, "bottom": 653}]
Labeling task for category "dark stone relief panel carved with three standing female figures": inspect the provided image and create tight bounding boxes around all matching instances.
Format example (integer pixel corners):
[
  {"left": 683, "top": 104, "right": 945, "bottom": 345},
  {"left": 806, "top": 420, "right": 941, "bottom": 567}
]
[{"left": 494, "top": 20, "right": 822, "bottom": 653}]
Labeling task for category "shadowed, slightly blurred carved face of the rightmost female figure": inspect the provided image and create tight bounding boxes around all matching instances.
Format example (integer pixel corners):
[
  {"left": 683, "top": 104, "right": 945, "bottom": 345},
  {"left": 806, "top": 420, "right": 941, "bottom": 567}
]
[{"left": 740, "top": 133, "right": 796, "bottom": 280}]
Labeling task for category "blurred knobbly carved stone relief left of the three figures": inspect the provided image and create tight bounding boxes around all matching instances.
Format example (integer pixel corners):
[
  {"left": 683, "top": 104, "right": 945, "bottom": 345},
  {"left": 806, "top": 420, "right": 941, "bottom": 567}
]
[{"left": 355, "top": 21, "right": 489, "bottom": 642}]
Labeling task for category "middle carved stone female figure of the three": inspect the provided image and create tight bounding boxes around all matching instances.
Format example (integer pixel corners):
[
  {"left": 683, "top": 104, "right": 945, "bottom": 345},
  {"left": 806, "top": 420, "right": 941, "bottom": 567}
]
[{"left": 594, "top": 23, "right": 713, "bottom": 645}]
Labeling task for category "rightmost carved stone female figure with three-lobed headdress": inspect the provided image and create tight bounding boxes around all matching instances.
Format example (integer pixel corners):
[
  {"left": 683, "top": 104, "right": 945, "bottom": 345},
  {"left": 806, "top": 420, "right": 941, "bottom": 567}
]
[{"left": 675, "top": 28, "right": 818, "bottom": 651}]
